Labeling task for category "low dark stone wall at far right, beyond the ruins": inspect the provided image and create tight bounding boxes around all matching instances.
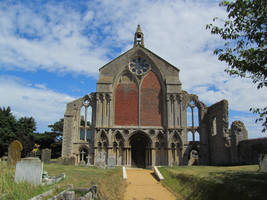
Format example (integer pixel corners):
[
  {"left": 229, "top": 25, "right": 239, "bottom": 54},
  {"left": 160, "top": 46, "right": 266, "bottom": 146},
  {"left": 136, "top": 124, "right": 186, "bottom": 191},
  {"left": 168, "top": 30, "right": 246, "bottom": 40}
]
[{"left": 237, "top": 138, "right": 267, "bottom": 165}]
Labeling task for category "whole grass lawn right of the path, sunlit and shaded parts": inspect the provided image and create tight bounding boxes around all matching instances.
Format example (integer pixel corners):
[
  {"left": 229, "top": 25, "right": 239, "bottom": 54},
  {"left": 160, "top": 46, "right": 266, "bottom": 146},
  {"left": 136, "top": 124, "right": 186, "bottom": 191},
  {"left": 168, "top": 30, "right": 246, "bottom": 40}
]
[{"left": 159, "top": 165, "right": 267, "bottom": 200}]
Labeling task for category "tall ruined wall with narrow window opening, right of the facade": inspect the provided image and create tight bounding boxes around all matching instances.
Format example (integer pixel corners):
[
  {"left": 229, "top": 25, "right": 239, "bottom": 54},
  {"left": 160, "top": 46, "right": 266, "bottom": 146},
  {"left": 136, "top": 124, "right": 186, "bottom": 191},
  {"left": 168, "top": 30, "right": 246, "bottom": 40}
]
[{"left": 206, "top": 100, "right": 231, "bottom": 165}]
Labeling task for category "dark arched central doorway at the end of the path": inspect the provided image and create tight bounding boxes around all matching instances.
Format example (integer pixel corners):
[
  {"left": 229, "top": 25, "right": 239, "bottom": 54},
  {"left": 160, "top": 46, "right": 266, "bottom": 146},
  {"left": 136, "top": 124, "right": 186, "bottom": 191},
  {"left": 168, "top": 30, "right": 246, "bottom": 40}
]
[{"left": 130, "top": 132, "right": 151, "bottom": 168}]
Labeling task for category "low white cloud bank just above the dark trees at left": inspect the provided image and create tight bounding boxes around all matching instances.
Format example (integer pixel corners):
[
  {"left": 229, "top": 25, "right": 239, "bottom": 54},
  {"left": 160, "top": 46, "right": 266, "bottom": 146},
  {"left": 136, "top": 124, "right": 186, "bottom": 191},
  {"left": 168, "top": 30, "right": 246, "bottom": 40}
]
[{"left": 0, "top": 76, "right": 74, "bottom": 130}]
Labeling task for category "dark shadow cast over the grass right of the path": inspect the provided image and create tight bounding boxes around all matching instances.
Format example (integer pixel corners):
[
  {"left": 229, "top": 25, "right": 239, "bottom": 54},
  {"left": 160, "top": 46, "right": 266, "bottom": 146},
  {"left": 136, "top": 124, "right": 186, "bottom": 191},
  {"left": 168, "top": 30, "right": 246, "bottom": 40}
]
[{"left": 171, "top": 171, "right": 267, "bottom": 200}]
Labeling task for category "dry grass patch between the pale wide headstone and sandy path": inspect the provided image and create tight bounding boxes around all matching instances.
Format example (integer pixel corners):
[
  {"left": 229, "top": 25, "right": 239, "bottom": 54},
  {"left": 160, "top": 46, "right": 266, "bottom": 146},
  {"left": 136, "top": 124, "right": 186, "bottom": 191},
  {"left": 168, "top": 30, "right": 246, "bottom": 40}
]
[{"left": 44, "top": 164, "right": 126, "bottom": 200}]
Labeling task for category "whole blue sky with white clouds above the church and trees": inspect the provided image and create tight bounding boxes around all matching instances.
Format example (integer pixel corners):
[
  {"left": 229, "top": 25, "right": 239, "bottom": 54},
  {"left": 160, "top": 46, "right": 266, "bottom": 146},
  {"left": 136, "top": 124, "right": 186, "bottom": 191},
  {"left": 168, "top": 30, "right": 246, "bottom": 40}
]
[{"left": 0, "top": 0, "right": 267, "bottom": 138}]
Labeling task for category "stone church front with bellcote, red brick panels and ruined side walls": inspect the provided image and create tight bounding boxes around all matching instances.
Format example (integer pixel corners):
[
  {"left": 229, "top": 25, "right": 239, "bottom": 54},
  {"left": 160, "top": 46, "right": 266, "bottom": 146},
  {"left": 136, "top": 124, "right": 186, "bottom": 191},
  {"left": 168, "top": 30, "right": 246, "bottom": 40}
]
[{"left": 62, "top": 25, "right": 248, "bottom": 167}]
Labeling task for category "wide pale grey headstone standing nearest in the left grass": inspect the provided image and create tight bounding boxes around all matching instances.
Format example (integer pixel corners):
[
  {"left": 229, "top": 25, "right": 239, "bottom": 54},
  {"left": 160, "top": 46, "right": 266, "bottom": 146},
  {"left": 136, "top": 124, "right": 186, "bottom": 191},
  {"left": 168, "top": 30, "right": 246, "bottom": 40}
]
[{"left": 15, "top": 157, "right": 43, "bottom": 185}]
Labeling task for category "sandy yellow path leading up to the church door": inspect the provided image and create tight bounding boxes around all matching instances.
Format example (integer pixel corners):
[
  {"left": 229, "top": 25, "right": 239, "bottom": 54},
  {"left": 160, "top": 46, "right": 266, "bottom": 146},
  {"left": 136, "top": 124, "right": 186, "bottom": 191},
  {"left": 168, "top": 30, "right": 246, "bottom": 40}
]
[{"left": 124, "top": 169, "right": 176, "bottom": 200}]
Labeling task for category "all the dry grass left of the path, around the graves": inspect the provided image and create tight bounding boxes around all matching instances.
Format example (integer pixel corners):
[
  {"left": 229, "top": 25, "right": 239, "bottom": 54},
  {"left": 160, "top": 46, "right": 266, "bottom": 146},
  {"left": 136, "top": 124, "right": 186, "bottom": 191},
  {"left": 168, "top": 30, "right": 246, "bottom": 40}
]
[{"left": 0, "top": 162, "right": 126, "bottom": 200}]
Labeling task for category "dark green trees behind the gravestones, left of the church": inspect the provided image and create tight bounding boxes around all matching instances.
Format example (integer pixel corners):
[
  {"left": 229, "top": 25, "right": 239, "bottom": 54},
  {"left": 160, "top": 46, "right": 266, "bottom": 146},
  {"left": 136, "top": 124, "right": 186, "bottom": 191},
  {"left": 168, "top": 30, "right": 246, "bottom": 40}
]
[{"left": 0, "top": 107, "right": 64, "bottom": 158}]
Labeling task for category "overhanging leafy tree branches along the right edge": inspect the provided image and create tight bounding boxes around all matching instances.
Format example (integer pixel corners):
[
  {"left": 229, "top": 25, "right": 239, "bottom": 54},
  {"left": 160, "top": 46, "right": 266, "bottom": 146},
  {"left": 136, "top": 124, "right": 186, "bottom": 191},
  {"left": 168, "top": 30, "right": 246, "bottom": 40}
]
[{"left": 206, "top": 0, "right": 267, "bottom": 132}]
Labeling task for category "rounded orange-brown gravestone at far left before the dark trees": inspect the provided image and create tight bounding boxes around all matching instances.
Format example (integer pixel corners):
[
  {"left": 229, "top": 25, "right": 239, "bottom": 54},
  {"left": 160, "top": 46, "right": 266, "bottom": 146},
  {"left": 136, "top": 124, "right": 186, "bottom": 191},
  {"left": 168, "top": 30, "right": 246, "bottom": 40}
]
[{"left": 8, "top": 140, "right": 23, "bottom": 166}]
